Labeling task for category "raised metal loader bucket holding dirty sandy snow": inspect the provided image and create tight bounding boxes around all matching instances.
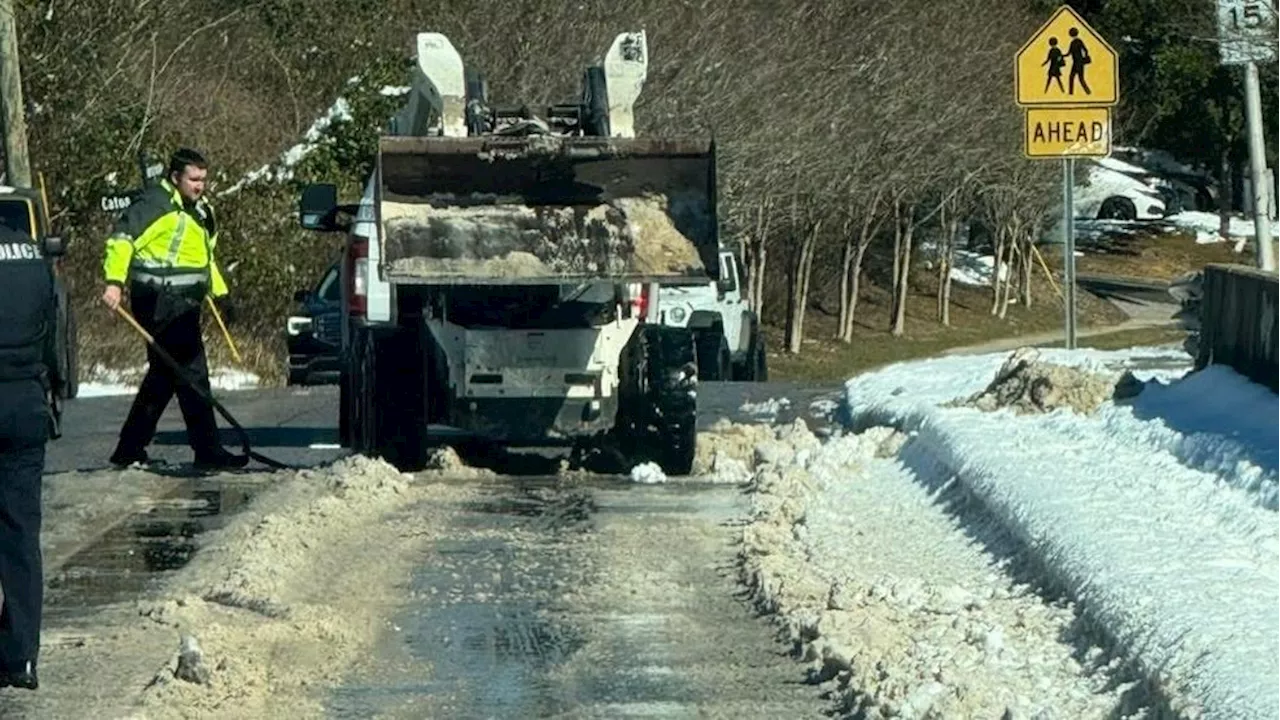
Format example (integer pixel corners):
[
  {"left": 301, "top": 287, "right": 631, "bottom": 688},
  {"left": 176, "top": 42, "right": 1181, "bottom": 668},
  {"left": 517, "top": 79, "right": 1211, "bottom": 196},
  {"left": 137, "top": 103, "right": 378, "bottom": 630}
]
[{"left": 375, "top": 136, "right": 719, "bottom": 284}]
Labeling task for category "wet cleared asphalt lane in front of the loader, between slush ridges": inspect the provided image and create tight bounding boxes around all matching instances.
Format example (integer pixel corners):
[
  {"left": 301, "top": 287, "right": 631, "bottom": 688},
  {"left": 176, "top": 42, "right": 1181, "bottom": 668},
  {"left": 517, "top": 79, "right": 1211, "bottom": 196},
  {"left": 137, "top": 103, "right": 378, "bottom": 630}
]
[{"left": 324, "top": 478, "right": 826, "bottom": 720}]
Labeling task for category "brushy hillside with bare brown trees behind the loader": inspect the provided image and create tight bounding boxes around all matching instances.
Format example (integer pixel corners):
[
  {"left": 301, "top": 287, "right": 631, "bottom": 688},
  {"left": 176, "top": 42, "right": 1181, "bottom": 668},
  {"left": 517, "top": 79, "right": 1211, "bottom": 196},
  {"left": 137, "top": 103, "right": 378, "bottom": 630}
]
[{"left": 10, "top": 0, "right": 1152, "bottom": 380}]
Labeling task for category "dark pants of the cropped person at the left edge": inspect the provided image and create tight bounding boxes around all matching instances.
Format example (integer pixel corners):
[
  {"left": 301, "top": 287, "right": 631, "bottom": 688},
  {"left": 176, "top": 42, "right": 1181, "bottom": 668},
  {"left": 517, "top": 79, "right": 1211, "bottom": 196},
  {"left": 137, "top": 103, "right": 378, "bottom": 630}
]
[{"left": 0, "top": 380, "right": 49, "bottom": 670}]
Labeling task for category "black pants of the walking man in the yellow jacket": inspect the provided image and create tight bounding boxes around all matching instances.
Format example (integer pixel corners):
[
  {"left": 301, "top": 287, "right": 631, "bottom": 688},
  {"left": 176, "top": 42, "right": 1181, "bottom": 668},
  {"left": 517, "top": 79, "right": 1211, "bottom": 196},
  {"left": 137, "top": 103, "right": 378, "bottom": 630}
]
[{"left": 116, "top": 283, "right": 223, "bottom": 459}]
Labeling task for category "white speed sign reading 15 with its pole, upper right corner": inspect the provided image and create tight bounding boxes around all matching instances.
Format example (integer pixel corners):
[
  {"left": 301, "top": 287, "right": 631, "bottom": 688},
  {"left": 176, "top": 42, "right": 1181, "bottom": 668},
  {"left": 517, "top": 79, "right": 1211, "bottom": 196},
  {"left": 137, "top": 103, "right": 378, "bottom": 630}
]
[{"left": 1217, "top": 0, "right": 1276, "bottom": 270}]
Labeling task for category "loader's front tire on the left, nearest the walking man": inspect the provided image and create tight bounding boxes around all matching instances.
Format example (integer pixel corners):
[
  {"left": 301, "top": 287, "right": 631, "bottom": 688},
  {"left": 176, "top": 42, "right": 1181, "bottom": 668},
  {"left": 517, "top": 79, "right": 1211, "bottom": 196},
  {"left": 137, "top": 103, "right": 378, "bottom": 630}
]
[{"left": 355, "top": 329, "right": 429, "bottom": 471}]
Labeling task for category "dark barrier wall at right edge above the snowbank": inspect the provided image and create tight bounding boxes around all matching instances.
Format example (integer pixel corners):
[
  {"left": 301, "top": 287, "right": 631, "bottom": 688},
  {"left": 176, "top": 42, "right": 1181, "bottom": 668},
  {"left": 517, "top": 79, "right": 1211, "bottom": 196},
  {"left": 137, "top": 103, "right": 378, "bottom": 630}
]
[{"left": 1196, "top": 264, "right": 1280, "bottom": 391}]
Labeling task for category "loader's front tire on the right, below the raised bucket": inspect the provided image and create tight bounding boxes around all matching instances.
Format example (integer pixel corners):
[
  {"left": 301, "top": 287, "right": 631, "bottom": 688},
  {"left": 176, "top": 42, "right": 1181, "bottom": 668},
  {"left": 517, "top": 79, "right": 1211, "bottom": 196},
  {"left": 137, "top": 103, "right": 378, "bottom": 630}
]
[{"left": 614, "top": 325, "right": 698, "bottom": 475}]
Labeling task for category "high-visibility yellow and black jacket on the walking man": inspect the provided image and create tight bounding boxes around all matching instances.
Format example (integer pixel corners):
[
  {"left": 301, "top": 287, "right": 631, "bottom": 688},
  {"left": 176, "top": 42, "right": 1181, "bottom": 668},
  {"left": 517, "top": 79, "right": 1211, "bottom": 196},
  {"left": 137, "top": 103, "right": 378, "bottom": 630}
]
[{"left": 102, "top": 179, "right": 228, "bottom": 297}]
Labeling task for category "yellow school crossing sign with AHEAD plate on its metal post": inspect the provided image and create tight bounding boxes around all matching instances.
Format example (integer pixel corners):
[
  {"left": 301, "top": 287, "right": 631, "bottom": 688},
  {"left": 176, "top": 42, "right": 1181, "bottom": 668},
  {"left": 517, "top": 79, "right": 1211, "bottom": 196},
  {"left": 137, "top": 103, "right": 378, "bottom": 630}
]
[{"left": 1014, "top": 5, "right": 1120, "bottom": 350}]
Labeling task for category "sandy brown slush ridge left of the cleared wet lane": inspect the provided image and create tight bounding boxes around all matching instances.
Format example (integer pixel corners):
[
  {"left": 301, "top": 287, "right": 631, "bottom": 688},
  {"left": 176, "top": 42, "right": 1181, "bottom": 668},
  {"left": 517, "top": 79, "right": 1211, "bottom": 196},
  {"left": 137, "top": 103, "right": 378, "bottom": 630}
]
[{"left": 0, "top": 456, "right": 486, "bottom": 719}]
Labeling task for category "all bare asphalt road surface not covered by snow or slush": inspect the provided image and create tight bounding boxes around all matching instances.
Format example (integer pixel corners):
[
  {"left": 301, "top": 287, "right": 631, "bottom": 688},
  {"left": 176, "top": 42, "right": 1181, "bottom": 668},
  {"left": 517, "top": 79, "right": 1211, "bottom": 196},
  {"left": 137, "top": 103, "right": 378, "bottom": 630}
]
[{"left": 20, "top": 383, "right": 840, "bottom": 719}]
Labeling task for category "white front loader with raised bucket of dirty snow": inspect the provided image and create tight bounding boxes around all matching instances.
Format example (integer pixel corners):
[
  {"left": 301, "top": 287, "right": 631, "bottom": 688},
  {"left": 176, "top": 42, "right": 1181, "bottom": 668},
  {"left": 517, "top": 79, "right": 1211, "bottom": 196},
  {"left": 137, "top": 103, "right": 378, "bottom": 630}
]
[{"left": 298, "top": 31, "right": 719, "bottom": 474}]
